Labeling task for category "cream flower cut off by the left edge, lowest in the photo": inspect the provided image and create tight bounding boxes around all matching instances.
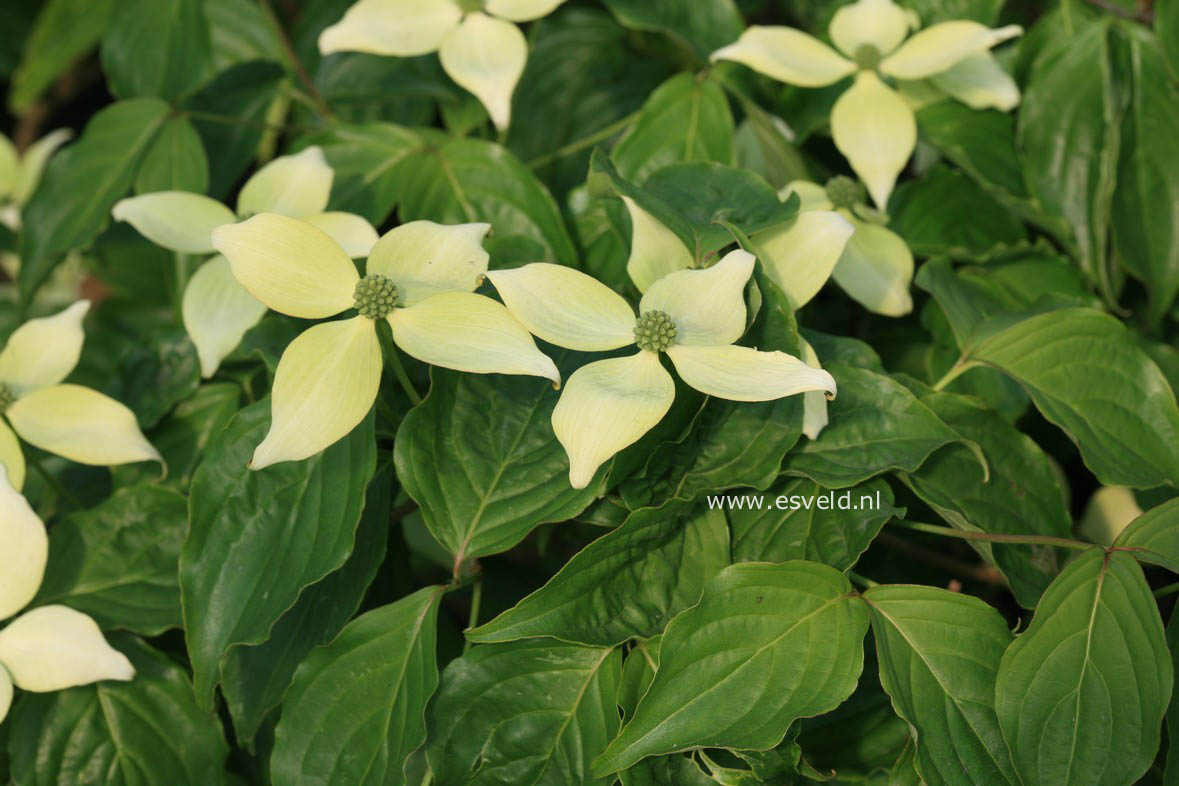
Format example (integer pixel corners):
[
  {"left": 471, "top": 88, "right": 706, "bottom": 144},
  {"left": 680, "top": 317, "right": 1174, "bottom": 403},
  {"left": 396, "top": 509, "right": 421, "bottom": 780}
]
[{"left": 0, "top": 467, "right": 136, "bottom": 721}]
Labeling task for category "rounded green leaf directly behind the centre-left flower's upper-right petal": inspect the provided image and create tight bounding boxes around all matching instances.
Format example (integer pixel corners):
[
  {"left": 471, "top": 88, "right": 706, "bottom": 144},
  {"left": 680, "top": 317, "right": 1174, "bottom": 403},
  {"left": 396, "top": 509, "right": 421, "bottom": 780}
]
[{"left": 396, "top": 139, "right": 578, "bottom": 265}]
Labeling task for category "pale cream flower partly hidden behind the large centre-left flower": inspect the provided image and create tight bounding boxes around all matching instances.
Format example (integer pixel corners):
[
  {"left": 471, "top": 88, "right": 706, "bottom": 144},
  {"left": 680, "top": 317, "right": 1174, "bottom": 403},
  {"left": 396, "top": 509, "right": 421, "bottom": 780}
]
[{"left": 111, "top": 147, "right": 376, "bottom": 377}]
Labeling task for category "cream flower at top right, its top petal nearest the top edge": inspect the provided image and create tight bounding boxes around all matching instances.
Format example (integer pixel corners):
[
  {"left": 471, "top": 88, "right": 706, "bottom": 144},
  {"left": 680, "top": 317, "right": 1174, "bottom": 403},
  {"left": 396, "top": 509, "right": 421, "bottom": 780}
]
[{"left": 712, "top": 0, "right": 1023, "bottom": 210}]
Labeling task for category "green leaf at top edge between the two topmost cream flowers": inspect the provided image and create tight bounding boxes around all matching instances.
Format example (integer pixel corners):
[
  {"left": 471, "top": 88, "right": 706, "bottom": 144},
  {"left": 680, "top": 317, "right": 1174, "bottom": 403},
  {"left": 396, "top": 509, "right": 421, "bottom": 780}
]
[{"left": 606, "top": 0, "right": 745, "bottom": 64}]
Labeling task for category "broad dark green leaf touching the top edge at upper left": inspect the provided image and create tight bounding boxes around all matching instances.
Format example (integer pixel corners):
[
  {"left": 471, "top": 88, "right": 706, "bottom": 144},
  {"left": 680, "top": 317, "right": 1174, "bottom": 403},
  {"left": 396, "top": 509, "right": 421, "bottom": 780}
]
[{"left": 103, "top": 0, "right": 212, "bottom": 98}]
